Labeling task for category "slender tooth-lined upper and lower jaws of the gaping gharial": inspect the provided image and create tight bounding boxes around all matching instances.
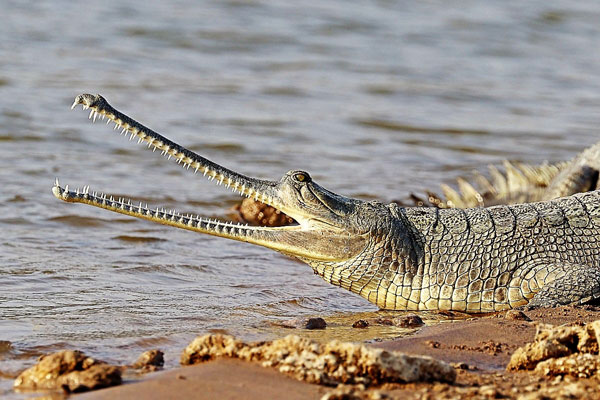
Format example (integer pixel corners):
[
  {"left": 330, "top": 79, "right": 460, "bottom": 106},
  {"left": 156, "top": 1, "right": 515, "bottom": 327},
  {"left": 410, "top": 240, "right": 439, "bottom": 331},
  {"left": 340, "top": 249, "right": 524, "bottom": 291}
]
[{"left": 52, "top": 94, "right": 298, "bottom": 238}]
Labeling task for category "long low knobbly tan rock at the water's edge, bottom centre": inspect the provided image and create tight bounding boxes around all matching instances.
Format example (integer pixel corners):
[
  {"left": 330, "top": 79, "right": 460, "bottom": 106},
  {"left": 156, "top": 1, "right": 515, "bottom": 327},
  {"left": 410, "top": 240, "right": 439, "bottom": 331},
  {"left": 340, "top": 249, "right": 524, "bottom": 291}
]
[{"left": 181, "top": 334, "right": 456, "bottom": 385}]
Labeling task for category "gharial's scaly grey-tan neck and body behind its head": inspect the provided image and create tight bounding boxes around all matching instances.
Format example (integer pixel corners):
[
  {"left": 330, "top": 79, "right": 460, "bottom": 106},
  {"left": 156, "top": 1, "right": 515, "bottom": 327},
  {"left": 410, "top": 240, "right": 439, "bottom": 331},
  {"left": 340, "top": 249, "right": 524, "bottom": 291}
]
[{"left": 305, "top": 191, "right": 600, "bottom": 312}]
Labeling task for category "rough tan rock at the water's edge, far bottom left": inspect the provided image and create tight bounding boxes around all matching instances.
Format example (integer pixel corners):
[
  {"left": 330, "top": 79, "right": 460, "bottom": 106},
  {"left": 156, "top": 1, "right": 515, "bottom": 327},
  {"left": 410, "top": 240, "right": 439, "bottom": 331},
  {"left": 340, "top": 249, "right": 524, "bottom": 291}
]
[{"left": 14, "top": 350, "right": 121, "bottom": 392}]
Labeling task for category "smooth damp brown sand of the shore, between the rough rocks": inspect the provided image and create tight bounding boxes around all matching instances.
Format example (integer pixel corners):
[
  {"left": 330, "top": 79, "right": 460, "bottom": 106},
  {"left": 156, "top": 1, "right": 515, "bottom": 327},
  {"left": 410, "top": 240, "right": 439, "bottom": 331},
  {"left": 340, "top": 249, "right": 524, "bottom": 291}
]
[{"left": 76, "top": 306, "right": 600, "bottom": 400}]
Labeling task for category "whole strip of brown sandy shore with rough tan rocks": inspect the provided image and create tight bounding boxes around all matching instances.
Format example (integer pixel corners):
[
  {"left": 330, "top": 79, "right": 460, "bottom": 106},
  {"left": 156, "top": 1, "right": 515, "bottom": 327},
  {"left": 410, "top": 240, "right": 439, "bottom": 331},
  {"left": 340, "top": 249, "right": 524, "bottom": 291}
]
[{"left": 8, "top": 306, "right": 600, "bottom": 400}]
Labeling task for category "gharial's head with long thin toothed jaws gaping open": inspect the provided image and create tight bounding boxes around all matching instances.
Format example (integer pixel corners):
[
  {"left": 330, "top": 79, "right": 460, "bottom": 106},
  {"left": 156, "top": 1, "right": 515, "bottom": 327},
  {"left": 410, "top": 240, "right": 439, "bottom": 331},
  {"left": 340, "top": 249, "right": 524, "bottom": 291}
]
[{"left": 52, "top": 94, "right": 386, "bottom": 263}]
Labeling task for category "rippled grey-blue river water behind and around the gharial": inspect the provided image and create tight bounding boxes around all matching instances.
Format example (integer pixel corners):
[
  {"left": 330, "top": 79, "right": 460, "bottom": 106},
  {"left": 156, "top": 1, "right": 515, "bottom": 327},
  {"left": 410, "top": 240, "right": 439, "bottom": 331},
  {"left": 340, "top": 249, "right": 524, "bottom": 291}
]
[{"left": 0, "top": 0, "right": 600, "bottom": 393}]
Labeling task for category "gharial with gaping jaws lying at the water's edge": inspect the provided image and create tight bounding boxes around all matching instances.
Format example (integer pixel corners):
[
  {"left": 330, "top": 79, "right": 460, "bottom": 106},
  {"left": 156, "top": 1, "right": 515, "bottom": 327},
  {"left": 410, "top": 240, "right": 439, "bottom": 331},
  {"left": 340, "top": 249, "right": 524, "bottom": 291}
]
[{"left": 52, "top": 94, "right": 600, "bottom": 313}]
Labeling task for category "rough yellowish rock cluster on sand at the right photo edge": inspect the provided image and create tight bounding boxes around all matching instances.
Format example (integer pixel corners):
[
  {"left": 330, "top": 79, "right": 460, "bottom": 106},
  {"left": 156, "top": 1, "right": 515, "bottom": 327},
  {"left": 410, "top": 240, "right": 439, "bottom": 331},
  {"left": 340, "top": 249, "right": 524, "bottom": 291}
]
[{"left": 507, "top": 320, "right": 600, "bottom": 377}]
